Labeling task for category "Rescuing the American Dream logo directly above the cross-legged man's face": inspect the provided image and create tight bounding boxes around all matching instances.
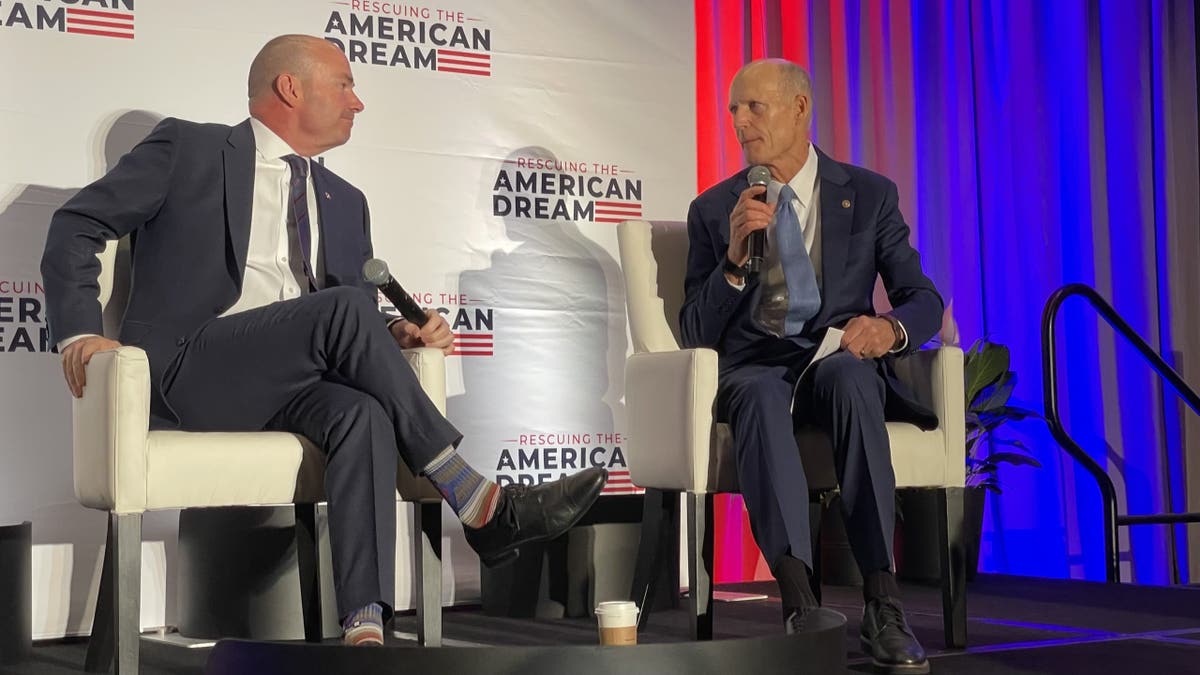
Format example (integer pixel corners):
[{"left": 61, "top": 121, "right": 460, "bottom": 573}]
[{"left": 323, "top": 0, "right": 492, "bottom": 77}]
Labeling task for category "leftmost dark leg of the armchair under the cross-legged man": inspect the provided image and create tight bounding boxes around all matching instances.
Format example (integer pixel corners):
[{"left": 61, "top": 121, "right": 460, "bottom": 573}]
[{"left": 84, "top": 513, "right": 142, "bottom": 675}]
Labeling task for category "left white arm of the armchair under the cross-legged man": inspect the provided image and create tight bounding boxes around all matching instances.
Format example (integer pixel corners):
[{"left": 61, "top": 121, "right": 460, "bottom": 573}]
[{"left": 71, "top": 347, "right": 150, "bottom": 513}]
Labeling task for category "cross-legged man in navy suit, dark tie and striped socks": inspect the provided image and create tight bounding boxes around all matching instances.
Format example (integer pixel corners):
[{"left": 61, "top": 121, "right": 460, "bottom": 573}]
[{"left": 42, "top": 35, "right": 606, "bottom": 645}]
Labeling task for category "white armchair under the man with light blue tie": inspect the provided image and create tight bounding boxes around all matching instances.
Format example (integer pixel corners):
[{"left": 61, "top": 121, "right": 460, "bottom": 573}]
[{"left": 617, "top": 221, "right": 966, "bottom": 646}]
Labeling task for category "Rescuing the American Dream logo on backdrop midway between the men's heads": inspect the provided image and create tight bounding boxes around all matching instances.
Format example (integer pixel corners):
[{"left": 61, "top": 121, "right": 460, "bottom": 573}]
[{"left": 492, "top": 151, "right": 642, "bottom": 222}]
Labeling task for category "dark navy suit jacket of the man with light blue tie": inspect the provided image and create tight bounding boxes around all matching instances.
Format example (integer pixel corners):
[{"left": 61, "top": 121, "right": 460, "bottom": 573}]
[{"left": 679, "top": 150, "right": 942, "bottom": 428}]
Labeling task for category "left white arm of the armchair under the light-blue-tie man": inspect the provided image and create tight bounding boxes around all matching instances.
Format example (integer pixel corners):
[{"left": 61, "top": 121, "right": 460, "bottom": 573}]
[{"left": 625, "top": 348, "right": 716, "bottom": 492}]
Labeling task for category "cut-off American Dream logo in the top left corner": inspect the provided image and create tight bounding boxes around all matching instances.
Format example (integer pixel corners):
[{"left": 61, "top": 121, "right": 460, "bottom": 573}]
[{"left": 0, "top": 0, "right": 133, "bottom": 40}]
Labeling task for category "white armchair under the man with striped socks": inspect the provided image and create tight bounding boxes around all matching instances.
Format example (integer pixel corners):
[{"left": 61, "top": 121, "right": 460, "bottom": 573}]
[{"left": 79, "top": 240, "right": 445, "bottom": 674}]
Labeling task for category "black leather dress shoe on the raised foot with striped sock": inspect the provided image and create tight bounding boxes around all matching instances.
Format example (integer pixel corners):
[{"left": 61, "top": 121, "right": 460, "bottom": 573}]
[{"left": 463, "top": 468, "right": 608, "bottom": 567}]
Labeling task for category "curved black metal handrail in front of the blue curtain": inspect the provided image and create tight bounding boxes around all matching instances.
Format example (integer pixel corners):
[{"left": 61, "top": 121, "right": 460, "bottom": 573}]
[{"left": 1042, "top": 283, "right": 1200, "bottom": 584}]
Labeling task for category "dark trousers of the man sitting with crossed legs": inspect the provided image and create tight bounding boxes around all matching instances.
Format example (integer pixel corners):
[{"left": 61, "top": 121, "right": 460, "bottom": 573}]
[{"left": 163, "top": 287, "right": 462, "bottom": 616}]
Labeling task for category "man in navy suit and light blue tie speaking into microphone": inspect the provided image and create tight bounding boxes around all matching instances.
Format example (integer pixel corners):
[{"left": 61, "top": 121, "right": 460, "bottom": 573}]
[{"left": 680, "top": 60, "right": 942, "bottom": 673}]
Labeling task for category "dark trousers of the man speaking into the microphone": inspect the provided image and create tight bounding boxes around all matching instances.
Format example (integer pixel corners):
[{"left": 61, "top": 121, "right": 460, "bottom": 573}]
[{"left": 718, "top": 352, "right": 895, "bottom": 575}]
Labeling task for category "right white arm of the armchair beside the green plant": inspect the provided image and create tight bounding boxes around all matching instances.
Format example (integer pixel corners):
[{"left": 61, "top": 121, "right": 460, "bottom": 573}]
[{"left": 895, "top": 346, "right": 966, "bottom": 485}]
